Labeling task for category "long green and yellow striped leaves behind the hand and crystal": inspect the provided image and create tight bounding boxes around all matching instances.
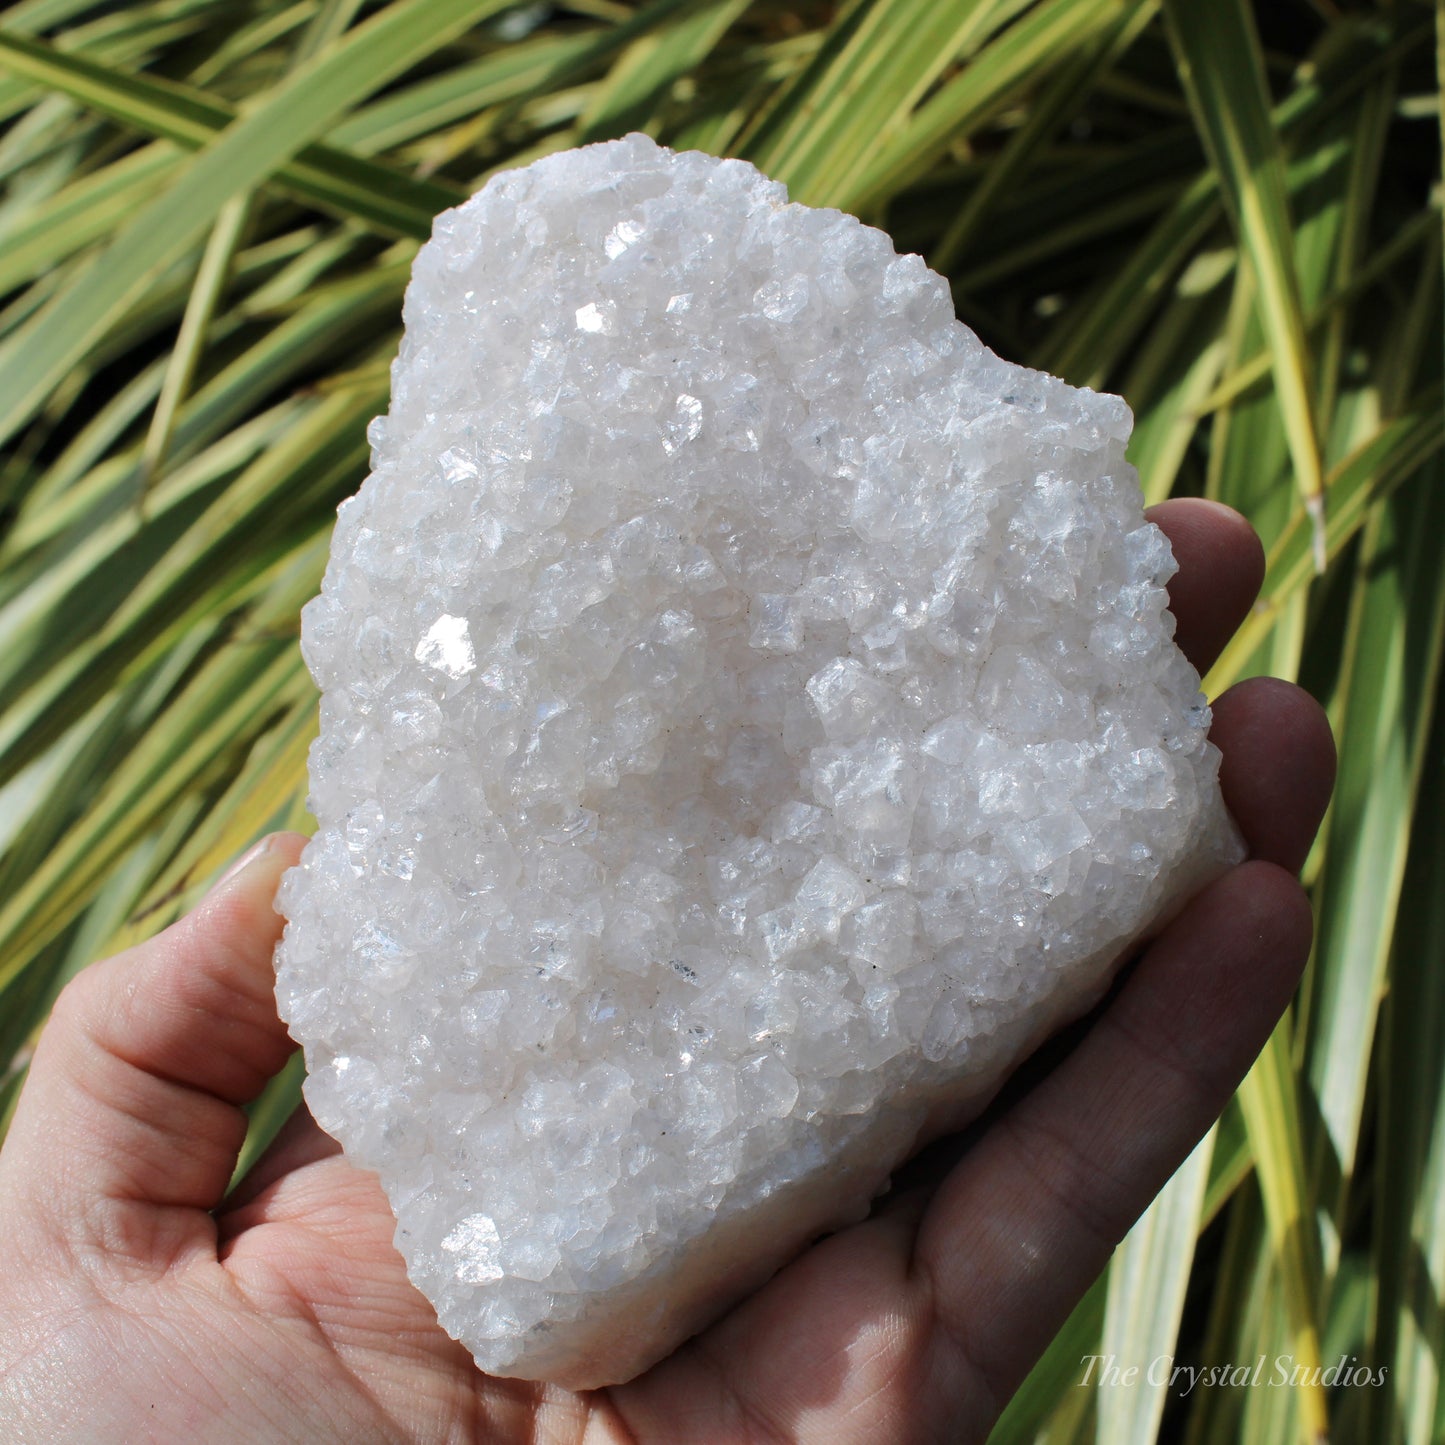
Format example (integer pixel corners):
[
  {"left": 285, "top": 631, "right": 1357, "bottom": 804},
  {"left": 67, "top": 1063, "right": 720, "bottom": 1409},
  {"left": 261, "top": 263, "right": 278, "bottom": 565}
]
[{"left": 0, "top": 0, "right": 1445, "bottom": 1445}]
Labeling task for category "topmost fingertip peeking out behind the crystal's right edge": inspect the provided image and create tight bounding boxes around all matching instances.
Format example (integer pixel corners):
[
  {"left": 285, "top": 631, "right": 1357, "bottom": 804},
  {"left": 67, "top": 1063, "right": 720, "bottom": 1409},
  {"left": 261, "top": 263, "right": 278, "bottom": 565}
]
[{"left": 1144, "top": 497, "right": 1264, "bottom": 675}]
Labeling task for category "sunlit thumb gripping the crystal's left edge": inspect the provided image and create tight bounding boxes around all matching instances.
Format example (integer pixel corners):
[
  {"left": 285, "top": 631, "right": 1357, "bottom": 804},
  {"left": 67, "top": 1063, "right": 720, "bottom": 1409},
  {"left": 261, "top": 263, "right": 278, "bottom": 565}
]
[{"left": 3, "top": 834, "right": 305, "bottom": 1263}]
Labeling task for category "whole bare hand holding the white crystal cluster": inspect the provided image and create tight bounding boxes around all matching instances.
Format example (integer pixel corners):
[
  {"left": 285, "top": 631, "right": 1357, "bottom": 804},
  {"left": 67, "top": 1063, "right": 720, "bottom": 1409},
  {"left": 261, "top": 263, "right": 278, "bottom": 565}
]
[{"left": 0, "top": 501, "right": 1334, "bottom": 1445}]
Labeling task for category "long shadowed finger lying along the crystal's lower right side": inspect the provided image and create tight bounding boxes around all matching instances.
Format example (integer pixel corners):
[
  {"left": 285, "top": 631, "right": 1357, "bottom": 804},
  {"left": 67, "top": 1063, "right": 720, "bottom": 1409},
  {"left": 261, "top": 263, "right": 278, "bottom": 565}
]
[{"left": 913, "top": 863, "right": 1312, "bottom": 1409}]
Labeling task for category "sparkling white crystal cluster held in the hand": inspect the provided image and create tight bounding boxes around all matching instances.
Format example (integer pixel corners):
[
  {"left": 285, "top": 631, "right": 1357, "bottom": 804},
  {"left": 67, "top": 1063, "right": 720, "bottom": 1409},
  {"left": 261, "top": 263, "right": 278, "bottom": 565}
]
[{"left": 277, "top": 136, "right": 1238, "bottom": 1386}]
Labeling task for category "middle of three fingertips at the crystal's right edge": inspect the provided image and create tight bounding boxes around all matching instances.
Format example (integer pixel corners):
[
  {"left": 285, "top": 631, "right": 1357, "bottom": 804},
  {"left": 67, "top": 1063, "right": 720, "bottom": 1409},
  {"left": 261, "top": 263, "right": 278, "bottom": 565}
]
[{"left": 1209, "top": 678, "right": 1335, "bottom": 873}]
